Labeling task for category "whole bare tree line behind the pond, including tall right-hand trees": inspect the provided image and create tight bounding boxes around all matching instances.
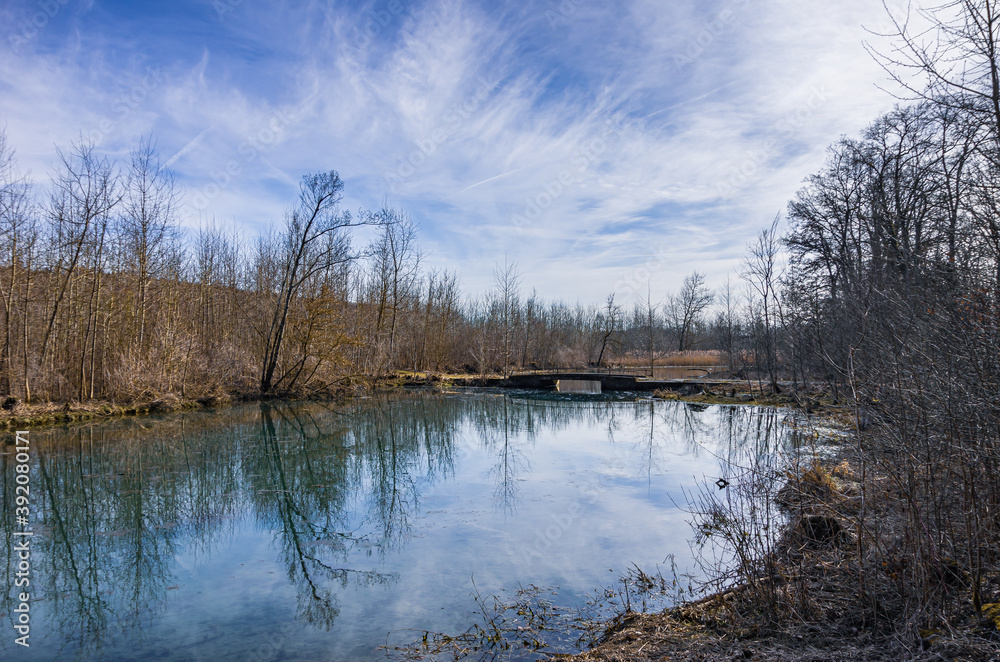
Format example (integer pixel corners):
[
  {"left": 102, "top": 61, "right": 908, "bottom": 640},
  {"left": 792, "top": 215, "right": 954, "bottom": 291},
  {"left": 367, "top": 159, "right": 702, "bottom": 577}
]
[{"left": 0, "top": 71, "right": 1000, "bottom": 410}]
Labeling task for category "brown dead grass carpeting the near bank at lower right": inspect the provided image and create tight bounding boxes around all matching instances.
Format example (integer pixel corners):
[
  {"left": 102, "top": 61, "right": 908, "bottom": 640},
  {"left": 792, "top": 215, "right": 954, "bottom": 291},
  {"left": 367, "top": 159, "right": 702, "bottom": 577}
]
[{"left": 554, "top": 452, "right": 1000, "bottom": 662}]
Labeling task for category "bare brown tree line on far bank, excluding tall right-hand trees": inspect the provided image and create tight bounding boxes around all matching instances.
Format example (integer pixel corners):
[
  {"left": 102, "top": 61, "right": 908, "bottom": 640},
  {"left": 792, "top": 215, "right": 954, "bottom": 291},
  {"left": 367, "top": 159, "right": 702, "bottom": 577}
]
[{"left": 0, "top": 132, "right": 772, "bottom": 402}]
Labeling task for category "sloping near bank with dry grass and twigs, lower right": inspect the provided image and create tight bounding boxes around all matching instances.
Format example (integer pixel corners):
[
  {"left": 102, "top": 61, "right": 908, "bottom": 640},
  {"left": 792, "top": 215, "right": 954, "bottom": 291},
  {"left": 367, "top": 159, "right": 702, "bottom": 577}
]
[{"left": 552, "top": 416, "right": 1000, "bottom": 662}]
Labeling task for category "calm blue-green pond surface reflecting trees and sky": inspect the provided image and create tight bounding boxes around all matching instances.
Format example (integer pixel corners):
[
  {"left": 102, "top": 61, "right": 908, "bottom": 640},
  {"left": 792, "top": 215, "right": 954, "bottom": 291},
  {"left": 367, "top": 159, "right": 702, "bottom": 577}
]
[{"left": 0, "top": 393, "right": 789, "bottom": 662}]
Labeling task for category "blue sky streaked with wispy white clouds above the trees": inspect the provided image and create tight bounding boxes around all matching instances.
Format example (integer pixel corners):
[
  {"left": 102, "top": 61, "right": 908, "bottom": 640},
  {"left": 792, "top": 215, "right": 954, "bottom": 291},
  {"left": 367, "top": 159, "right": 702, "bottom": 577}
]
[{"left": 0, "top": 0, "right": 905, "bottom": 302}]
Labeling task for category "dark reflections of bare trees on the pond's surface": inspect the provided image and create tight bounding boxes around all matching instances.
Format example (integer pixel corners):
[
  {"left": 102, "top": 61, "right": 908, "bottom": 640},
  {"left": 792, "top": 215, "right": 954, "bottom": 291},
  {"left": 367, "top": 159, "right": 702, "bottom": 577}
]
[{"left": 0, "top": 394, "right": 796, "bottom": 657}]
